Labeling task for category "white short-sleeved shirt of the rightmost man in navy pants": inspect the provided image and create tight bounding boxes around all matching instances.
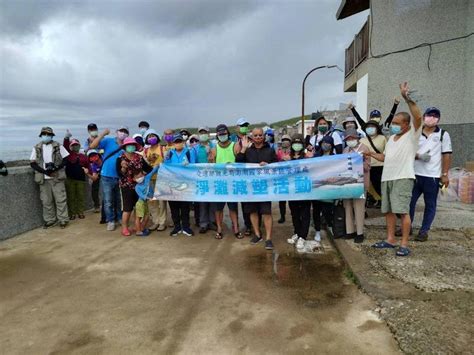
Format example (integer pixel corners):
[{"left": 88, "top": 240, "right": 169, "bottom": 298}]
[{"left": 415, "top": 127, "right": 453, "bottom": 178}]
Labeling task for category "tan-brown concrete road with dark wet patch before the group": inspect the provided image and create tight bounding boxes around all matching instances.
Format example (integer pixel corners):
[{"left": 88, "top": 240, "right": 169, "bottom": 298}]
[{"left": 0, "top": 214, "right": 398, "bottom": 354}]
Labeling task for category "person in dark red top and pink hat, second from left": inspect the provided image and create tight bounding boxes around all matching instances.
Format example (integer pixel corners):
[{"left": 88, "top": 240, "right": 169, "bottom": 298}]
[{"left": 63, "top": 134, "right": 89, "bottom": 220}]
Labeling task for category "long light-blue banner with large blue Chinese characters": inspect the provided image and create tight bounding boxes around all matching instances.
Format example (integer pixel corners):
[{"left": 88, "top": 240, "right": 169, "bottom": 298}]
[{"left": 154, "top": 154, "right": 364, "bottom": 202}]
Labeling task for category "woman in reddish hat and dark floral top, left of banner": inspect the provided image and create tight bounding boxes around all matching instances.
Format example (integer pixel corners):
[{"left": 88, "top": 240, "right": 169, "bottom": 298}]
[{"left": 116, "top": 137, "right": 152, "bottom": 237}]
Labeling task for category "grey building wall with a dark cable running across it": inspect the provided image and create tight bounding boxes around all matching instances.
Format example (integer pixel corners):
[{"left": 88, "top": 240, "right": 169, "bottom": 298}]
[{"left": 368, "top": 0, "right": 474, "bottom": 165}]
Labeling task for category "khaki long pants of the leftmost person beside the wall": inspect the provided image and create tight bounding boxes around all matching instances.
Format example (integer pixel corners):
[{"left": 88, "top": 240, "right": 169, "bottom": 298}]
[{"left": 40, "top": 179, "right": 69, "bottom": 223}]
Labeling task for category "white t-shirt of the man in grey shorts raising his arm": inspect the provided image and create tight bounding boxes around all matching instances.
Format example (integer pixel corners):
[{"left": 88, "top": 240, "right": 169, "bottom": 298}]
[{"left": 382, "top": 126, "right": 422, "bottom": 181}]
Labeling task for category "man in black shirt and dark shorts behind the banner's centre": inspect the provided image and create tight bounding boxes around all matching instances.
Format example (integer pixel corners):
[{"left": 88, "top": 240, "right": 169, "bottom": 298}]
[{"left": 236, "top": 128, "right": 277, "bottom": 250}]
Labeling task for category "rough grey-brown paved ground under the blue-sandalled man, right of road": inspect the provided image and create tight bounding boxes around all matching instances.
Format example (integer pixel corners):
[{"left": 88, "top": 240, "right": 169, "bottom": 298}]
[{"left": 336, "top": 203, "right": 474, "bottom": 354}]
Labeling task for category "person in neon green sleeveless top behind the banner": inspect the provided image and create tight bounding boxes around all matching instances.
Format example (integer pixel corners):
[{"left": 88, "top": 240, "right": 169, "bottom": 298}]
[{"left": 211, "top": 124, "right": 243, "bottom": 239}]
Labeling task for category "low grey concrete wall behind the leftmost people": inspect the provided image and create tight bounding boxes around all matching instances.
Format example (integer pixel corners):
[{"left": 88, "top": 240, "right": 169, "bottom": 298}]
[{"left": 0, "top": 166, "right": 93, "bottom": 240}]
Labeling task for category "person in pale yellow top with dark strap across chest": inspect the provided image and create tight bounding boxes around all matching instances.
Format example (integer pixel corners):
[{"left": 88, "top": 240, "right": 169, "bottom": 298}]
[{"left": 360, "top": 120, "right": 387, "bottom": 208}]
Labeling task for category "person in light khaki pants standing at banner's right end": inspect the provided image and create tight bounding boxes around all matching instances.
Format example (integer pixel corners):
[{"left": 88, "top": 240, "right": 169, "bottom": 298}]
[{"left": 343, "top": 128, "right": 370, "bottom": 243}]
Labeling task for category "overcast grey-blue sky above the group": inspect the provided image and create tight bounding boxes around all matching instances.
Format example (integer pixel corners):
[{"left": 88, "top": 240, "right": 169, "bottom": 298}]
[{"left": 0, "top": 0, "right": 367, "bottom": 154}]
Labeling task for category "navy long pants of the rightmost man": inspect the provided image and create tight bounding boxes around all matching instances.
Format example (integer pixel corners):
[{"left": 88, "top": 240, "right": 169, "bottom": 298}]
[{"left": 410, "top": 175, "right": 439, "bottom": 233}]
